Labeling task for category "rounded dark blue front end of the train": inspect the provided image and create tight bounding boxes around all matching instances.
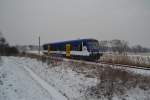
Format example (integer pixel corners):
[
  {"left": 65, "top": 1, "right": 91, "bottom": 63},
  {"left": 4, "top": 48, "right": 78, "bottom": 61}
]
[{"left": 87, "top": 40, "right": 102, "bottom": 60}]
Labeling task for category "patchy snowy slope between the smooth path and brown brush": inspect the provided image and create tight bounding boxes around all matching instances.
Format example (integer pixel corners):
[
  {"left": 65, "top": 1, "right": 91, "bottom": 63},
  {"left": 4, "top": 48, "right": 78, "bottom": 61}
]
[{"left": 13, "top": 58, "right": 97, "bottom": 100}]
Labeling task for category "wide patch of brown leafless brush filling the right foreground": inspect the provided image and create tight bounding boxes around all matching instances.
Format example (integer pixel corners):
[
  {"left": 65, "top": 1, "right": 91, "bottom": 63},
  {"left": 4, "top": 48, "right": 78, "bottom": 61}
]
[{"left": 88, "top": 66, "right": 150, "bottom": 100}]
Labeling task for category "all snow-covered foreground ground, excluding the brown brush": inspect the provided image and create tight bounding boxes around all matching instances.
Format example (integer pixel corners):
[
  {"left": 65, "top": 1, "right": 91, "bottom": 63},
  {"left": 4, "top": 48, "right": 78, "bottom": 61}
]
[{"left": 0, "top": 57, "right": 150, "bottom": 100}]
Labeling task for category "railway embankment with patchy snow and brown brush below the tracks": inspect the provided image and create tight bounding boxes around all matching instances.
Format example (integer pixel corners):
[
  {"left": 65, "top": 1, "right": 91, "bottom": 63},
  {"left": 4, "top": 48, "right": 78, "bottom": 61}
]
[{"left": 11, "top": 54, "right": 150, "bottom": 100}]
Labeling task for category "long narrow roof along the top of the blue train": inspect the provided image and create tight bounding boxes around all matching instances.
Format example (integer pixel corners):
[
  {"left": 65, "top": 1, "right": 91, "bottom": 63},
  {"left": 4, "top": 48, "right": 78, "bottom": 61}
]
[{"left": 44, "top": 38, "right": 97, "bottom": 45}]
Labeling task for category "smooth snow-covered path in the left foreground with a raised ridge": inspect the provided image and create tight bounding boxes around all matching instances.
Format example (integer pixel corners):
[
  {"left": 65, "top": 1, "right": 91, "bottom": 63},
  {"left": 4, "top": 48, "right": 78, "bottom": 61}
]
[{"left": 0, "top": 57, "right": 67, "bottom": 100}]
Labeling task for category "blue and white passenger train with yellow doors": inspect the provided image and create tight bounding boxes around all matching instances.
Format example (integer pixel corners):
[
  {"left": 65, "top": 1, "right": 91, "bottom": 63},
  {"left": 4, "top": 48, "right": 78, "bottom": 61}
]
[{"left": 43, "top": 39, "right": 102, "bottom": 61}]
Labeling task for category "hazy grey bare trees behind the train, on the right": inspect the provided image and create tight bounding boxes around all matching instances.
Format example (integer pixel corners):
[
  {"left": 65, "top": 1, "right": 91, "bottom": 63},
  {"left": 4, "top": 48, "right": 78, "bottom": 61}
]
[{"left": 99, "top": 39, "right": 150, "bottom": 54}]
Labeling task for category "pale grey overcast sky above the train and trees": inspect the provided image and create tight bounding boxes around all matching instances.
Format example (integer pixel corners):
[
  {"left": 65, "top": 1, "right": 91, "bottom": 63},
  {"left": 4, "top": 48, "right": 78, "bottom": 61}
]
[{"left": 0, "top": 0, "right": 150, "bottom": 47}]
